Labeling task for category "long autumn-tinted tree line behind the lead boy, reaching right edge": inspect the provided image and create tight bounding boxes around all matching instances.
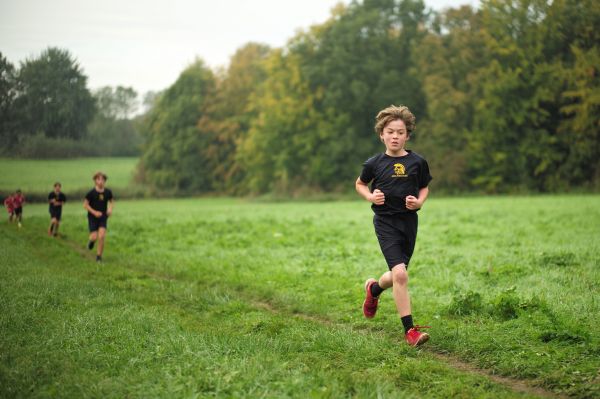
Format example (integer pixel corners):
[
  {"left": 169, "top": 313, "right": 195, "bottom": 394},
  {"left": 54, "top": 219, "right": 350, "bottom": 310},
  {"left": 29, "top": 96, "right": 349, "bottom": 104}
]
[{"left": 139, "top": 0, "right": 600, "bottom": 194}]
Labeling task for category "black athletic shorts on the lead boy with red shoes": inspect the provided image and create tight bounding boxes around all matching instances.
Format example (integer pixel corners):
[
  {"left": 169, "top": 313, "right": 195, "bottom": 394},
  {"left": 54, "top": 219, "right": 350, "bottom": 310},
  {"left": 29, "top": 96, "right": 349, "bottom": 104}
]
[{"left": 373, "top": 212, "right": 419, "bottom": 270}]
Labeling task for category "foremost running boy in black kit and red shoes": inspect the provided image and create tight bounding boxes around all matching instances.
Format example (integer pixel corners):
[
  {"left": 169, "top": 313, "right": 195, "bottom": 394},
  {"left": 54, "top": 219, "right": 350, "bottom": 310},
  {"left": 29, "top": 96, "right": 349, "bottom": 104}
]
[{"left": 355, "top": 105, "right": 431, "bottom": 346}]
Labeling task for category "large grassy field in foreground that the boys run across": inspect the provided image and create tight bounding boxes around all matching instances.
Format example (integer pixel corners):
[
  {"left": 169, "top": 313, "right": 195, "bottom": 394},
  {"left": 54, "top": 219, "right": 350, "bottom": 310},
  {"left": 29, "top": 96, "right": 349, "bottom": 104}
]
[{"left": 0, "top": 196, "right": 600, "bottom": 398}]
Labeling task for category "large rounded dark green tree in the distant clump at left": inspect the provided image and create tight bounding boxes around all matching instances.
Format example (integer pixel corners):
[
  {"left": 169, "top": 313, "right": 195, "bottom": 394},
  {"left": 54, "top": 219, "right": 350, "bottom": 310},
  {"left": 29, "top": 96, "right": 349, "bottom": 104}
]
[{"left": 15, "top": 47, "right": 95, "bottom": 139}]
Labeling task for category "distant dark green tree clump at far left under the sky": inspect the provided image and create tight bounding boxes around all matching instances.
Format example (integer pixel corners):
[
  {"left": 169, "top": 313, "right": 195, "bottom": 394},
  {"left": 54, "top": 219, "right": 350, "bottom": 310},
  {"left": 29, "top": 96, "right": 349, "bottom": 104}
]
[{"left": 0, "top": 47, "right": 142, "bottom": 158}]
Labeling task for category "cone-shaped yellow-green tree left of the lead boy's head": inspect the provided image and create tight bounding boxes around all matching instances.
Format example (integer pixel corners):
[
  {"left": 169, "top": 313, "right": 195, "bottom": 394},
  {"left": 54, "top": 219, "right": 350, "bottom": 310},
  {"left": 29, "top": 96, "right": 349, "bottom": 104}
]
[{"left": 237, "top": 50, "right": 330, "bottom": 193}]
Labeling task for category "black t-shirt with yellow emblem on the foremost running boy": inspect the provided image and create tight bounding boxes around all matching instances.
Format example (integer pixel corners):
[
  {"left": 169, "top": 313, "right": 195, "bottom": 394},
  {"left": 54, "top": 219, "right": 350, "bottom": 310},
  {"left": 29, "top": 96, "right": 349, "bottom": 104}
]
[{"left": 360, "top": 151, "right": 431, "bottom": 215}]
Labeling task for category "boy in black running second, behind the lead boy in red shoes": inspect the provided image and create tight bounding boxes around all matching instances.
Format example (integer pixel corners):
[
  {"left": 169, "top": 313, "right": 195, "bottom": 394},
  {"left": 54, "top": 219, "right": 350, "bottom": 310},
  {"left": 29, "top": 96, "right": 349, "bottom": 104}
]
[{"left": 83, "top": 172, "right": 113, "bottom": 262}]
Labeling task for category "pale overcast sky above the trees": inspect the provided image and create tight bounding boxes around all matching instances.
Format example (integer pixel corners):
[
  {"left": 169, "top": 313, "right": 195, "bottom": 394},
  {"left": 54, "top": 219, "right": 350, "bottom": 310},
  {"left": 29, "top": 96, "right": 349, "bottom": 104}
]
[{"left": 0, "top": 0, "right": 479, "bottom": 93}]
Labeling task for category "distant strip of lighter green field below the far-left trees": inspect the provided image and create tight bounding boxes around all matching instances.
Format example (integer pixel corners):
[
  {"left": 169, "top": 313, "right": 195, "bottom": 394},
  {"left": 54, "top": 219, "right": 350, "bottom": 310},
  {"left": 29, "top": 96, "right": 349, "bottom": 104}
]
[{"left": 0, "top": 158, "right": 137, "bottom": 195}]
